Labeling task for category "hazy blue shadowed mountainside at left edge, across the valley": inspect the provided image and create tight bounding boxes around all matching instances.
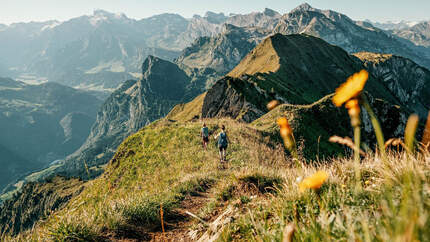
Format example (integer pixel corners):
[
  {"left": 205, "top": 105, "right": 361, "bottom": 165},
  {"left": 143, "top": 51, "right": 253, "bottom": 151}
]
[{"left": 0, "top": 78, "right": 101, "bottom": 193}]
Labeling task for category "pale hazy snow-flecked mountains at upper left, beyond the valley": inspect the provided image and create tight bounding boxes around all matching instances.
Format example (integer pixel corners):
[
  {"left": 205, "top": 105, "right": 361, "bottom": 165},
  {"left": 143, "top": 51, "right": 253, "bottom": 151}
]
[{"left": 0, "top": 10, "right": 282, "bottom": 89}]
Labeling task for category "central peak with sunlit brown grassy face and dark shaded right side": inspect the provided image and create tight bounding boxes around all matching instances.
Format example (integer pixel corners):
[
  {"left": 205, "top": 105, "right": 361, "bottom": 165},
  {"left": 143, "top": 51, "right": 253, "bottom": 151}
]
[{"left": 202, "top": 34, "right": 400, "bottom": 122}]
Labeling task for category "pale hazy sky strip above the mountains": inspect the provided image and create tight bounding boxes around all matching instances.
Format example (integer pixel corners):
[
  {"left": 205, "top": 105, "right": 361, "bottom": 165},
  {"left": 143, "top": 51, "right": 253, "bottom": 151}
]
[{"left": 0, "top": 0, "right": 430, "bottom": 24}]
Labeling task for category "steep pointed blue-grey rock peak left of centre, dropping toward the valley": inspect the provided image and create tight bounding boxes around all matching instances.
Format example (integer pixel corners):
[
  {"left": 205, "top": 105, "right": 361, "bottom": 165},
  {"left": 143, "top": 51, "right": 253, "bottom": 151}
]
[{"left": 50, "top": 56, "right": 190, "bottom": 175}]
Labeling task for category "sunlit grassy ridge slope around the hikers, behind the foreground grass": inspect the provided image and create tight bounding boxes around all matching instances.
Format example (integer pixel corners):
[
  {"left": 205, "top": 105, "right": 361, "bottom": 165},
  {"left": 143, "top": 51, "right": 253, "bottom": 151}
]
[{"left": 10, "top": 117, "right": 285, "bottom": 240}]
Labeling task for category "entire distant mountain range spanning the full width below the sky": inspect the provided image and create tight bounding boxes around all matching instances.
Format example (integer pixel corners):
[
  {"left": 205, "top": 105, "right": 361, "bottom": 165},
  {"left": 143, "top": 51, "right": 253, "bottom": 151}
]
[{"left": 0, "top": 4, "right": 430, "bottom": 92}]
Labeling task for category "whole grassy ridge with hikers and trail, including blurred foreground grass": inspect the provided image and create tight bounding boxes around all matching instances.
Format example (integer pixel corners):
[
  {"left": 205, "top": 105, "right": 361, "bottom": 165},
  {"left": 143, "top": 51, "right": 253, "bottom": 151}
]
[{"left": 6, "top": 116, "right": 430, "bottom": 241}]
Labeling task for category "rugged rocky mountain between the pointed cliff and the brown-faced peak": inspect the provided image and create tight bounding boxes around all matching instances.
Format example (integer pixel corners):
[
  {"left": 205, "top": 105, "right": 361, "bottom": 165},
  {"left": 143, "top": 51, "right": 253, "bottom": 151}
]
[{"left": 175, "top": 24, "right": 270, "bottom": 92}]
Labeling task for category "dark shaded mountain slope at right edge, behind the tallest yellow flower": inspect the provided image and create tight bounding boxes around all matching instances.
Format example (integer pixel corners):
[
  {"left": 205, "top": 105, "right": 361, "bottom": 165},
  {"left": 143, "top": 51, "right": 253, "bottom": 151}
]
[{"left": 354, "top": 52, "right": 430, "bottom": 119}]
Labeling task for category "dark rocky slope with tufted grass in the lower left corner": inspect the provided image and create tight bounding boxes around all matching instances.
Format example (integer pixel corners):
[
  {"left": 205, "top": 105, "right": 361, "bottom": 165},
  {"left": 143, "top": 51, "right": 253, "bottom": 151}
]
[{"left": 0, "top": 177, "right": 84, "bottom": 235}]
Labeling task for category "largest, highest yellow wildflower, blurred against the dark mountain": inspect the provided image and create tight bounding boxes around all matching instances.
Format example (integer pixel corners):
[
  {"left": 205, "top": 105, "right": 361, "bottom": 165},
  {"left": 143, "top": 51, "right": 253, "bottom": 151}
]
[{"left": 333, "top": 70, "right": 369, "bottom": 107}]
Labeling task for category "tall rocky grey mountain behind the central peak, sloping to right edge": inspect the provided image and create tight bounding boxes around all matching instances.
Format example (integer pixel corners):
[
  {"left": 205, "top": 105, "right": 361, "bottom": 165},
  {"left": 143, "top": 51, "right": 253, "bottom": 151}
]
[{"left": 274, "top": 4, "right": 430, "bottom": 67}]
